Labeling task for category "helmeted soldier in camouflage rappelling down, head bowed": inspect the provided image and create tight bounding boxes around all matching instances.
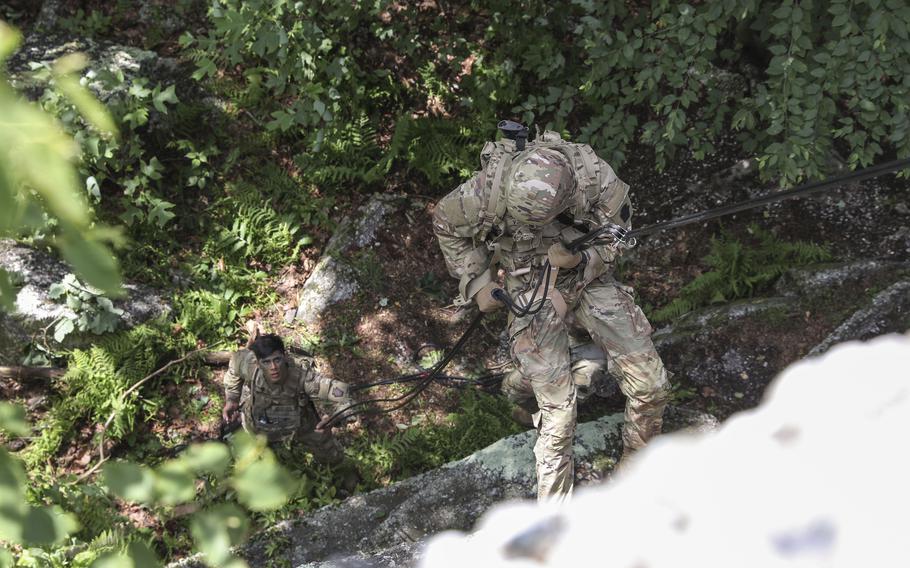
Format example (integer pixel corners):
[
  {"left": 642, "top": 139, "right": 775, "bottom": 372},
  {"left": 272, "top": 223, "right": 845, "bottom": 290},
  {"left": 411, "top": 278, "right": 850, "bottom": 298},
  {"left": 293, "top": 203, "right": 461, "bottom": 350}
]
[{"left": 434, "top": 131, "right": 669, "bottom": 500}]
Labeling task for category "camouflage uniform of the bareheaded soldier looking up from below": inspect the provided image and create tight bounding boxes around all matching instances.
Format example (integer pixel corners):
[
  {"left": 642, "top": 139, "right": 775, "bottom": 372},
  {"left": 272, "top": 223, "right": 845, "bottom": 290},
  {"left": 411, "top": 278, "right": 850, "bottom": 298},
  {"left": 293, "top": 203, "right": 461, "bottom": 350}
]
[{"left": 224, "top": 349, "right": 351, "bottom": 465}]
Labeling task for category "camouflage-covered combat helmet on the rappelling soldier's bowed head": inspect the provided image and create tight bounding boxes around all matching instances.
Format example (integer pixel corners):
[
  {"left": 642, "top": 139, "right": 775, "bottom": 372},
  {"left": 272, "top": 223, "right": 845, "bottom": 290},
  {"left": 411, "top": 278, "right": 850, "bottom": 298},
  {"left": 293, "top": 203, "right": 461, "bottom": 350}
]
[{"left": 506, "top": 148, "right": 575, "bottom": 226}]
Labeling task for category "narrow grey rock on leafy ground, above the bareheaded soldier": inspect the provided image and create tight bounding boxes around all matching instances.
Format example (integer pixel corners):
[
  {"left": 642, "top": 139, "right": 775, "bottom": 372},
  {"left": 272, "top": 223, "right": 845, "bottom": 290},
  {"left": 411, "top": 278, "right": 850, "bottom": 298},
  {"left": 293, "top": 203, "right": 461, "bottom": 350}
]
[{"left": 294, "top": 194, "right": 401, "bottom": 325}]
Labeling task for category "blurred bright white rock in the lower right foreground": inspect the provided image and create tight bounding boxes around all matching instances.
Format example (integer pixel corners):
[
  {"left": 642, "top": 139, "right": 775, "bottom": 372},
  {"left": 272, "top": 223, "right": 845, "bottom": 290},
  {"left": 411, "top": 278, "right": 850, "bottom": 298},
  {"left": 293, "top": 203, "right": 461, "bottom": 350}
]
[{"left": 420, "top": 335, "right": 910, "bottom": 568}]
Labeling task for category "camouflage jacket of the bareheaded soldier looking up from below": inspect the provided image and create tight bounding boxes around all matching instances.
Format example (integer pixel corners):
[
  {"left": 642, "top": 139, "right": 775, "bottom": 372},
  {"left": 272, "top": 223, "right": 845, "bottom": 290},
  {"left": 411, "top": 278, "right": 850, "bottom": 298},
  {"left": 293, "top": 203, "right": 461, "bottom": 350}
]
[{"left": 224, "top": 349, "right": 351, "bottom": 438}]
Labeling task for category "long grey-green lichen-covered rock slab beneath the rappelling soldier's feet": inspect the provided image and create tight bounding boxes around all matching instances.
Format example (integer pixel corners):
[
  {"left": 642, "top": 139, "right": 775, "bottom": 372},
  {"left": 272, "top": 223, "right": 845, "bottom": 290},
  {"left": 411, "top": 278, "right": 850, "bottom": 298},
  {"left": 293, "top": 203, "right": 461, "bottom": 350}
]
[{"left": 167, "top": 410, "right": 717, "bottom": 566}]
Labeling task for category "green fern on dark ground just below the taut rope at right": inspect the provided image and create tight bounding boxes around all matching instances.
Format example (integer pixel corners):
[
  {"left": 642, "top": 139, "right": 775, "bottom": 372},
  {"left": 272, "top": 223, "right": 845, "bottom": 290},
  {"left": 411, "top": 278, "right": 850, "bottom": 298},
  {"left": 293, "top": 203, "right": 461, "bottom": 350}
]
[{"left": 650, "top": 224, "right": 831, "bottom": 322}]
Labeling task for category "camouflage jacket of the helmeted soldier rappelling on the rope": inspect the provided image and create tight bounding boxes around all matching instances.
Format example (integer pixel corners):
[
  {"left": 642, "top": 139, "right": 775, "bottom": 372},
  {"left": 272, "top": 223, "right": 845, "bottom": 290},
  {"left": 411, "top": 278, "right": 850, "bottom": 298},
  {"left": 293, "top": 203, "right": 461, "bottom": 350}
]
[{"left": 433, "top": 131, "right": 632, "bottom": 301}]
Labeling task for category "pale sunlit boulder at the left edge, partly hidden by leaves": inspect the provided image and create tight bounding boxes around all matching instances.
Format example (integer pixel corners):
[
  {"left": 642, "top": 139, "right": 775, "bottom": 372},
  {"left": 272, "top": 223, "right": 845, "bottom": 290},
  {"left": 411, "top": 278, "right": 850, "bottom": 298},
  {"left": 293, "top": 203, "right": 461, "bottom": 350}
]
[{"left": 0, "top": 240, "right": 170, "bottom": 365}]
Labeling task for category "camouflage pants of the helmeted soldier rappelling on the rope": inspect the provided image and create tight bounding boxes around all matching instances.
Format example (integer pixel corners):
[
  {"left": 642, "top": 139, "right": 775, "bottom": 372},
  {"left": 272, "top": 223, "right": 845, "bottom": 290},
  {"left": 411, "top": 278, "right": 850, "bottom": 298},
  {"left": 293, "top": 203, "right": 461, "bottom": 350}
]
[{"left": 503, "top": 281, "right": 669, "bottom": 500}]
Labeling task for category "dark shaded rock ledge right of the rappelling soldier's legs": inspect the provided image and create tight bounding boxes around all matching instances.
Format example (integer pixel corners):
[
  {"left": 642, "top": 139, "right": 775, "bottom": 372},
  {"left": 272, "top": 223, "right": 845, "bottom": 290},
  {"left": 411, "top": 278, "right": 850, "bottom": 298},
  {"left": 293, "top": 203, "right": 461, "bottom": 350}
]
[{"left": 653, "top": 261, "right": 910, "bottom": 418}]
